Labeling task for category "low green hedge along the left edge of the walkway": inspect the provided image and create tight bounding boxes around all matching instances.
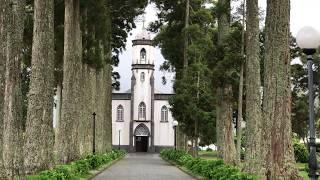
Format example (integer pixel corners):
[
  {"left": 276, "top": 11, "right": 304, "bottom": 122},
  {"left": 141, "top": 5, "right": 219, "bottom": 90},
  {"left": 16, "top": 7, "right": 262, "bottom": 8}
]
[{"left": 26, "top": 150, "right": 125, "bottom": 180}]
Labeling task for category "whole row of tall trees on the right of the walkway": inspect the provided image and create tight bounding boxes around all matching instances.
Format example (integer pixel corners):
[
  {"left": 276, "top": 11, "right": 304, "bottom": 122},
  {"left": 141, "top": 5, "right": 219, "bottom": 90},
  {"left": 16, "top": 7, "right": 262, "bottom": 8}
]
[{"left": 150, "top": 0, "right": 305, "bottom": 179}]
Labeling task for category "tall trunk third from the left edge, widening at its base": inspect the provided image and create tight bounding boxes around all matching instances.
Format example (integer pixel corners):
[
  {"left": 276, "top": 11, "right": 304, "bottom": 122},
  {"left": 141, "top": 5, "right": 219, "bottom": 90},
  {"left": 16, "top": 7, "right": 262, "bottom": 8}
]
[{"left": 56, "top": 0, "right": 82, "bottom": 163}]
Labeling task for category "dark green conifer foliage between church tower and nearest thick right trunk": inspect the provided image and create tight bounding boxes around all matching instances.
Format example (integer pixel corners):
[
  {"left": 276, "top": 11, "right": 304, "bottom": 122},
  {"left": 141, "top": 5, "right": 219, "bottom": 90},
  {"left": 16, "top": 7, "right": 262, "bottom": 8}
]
[{"left": 149, "top": 0, "right": 215, "bottom": 144}]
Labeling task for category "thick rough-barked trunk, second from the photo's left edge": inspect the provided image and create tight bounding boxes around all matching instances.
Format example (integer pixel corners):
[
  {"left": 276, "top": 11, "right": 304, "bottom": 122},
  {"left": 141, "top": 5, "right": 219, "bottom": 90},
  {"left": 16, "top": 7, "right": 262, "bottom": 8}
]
[{"left": 24, "top": 0, "right": 54, "bottom": 174}]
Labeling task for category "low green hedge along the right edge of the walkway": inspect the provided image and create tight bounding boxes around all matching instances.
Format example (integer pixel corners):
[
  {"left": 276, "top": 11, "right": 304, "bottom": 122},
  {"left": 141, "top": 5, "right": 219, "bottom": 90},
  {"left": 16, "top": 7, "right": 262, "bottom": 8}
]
[{"left": 160, "top": 149, "right": 258, "bottom": 180}]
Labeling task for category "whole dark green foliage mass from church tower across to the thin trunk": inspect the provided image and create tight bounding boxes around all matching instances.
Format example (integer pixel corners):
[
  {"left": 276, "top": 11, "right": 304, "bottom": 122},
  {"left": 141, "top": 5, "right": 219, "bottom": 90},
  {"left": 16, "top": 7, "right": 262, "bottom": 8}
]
[{"left": 149, "top": 0, "right": 243, "bottom": 145}]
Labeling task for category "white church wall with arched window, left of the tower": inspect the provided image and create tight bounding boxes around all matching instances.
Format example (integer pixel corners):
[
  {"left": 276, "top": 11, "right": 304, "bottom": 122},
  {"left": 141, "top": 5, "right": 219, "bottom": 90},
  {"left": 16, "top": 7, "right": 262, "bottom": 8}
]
[{"left": 112, "top": 100, "right": 131, "bottom": 145}]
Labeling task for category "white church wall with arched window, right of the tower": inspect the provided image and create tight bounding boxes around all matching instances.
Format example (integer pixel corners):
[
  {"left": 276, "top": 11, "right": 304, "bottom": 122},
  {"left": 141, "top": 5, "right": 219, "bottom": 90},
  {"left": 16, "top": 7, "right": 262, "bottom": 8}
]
[{"left": 154, "top": 100, "right": 174, "bottom": 146}]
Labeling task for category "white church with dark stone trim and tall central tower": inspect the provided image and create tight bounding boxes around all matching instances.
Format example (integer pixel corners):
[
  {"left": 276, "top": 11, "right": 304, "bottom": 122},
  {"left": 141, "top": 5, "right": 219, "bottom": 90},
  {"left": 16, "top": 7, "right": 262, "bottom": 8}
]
[{"left": 112, "top": 29, "right": 178, "bottom": 152}]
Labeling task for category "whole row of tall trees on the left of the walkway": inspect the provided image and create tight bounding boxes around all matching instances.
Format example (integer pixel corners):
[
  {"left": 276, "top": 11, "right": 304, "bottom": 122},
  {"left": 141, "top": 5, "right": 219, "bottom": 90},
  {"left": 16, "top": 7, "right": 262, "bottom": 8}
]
[{"left": 0, "top": 0, "right": 147, "bottom": 179}]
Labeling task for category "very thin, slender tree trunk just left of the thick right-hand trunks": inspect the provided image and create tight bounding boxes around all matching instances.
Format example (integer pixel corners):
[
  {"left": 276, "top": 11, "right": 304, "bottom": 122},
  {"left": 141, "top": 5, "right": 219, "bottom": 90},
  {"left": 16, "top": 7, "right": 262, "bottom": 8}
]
[{"left": 236, "top": 0, "right": 246, "bottom": 164}]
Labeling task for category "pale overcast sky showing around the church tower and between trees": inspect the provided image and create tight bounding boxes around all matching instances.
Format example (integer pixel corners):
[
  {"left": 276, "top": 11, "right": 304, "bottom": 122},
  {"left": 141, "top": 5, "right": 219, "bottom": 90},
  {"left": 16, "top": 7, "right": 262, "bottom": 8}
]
[{"left": 115, "top": 0, "right": 320, "bottom": 93}]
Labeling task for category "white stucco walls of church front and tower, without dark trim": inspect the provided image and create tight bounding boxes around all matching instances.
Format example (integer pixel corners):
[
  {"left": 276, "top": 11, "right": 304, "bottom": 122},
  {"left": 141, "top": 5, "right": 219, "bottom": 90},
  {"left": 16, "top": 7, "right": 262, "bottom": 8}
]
[{"left": 112, "top": 35, "right": 174, "bottom": 149}]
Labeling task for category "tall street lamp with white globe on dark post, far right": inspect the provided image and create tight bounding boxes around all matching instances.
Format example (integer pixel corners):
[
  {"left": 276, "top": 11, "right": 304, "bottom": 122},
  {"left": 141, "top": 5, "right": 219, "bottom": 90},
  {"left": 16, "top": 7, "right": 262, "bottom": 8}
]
[{"left": 297, "top": 27, "right": 320, "bottom": 180}]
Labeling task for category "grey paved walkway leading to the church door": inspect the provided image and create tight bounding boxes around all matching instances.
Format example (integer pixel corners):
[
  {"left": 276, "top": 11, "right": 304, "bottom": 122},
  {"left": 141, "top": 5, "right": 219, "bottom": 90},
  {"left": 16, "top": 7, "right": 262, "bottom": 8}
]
[{"left": 94, "top": 153, "right": 194, "bottom": 180}]
